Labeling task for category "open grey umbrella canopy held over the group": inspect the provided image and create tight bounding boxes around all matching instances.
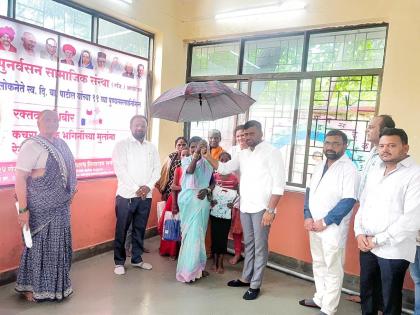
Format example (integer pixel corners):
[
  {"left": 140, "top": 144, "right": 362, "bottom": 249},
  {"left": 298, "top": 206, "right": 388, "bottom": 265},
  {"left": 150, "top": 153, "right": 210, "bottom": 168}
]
[{"left": 151, "top": 81, "right": 255, "bottom": 122}]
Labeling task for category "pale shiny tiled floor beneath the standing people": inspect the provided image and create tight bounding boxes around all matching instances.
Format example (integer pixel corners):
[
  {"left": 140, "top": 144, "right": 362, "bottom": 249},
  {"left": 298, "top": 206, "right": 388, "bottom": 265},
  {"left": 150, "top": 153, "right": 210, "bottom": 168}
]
[{"left": 0, "top": 237, "right": 360, "bottom": 315}]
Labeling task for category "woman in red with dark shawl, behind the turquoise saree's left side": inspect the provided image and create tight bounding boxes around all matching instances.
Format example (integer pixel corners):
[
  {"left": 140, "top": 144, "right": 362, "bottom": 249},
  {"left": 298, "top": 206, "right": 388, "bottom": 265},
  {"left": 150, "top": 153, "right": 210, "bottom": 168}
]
[{"left": 156, "top": 137, "right": 187, "bottom": 259}]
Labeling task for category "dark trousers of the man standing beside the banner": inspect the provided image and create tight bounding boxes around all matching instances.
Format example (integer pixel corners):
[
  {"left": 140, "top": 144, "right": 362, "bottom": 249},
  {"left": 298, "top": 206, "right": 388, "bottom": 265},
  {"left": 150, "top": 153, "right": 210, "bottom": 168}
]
[{"left": 114, "top": 196, "right": 152, "bottom": 265}]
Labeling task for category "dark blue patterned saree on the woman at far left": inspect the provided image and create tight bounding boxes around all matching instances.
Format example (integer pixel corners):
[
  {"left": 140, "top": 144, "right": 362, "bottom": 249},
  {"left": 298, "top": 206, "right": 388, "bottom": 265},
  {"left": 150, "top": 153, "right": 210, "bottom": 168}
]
[{"left": 15, "top": 136, "right": 76, "bottom": 301}]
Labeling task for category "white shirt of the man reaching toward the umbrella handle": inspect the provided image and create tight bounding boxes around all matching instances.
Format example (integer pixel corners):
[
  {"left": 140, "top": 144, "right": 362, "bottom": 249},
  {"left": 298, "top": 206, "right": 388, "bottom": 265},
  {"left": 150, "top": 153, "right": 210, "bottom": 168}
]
[{"left": 217, "top": 142, "right": 286, "bottom": 213}]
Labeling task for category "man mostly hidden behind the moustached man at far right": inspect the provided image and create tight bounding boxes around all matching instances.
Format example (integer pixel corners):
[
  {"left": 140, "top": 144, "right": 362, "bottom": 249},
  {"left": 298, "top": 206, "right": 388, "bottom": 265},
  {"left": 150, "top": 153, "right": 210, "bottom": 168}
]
[{"left": 358, "top": 115, "right": 395, "bottom": 198}]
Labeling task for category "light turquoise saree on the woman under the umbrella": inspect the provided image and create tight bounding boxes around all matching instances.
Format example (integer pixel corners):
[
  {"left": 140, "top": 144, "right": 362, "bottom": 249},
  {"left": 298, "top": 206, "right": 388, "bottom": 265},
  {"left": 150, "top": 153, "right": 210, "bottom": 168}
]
[{"left": 176, "top": 157, "right": 213, "bottom": 282}]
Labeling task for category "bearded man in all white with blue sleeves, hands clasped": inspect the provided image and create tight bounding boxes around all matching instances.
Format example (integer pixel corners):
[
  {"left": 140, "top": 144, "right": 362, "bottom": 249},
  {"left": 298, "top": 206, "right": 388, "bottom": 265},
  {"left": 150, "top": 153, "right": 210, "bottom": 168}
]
[{"left": 299, "top": 130, "right": 359, "bottom": 315}]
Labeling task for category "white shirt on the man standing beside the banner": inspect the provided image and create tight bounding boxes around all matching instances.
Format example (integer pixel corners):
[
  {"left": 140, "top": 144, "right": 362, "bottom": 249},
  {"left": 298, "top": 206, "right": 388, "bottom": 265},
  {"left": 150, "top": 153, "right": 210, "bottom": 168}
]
[{"left": 112, "top": 136, "right": 160, "bottom": 198}]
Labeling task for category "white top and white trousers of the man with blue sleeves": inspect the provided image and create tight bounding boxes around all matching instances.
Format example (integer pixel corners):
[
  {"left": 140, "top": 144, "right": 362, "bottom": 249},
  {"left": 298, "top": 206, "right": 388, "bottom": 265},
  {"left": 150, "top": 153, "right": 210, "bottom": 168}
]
[{"left": 309, "top": 155, "right": 359, "bottom": 315}]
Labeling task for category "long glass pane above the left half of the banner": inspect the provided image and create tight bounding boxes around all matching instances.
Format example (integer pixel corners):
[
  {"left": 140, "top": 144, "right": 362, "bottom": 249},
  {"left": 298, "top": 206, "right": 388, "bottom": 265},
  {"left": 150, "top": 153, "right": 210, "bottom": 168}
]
[{"left": 16, "top": 0, "right": 92, "bottom": 41}]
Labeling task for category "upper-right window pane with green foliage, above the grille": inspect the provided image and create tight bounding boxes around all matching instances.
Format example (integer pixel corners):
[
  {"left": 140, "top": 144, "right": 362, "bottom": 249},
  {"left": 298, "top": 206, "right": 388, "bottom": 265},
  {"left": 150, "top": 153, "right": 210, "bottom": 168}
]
[{"left": 307, "top": 27, "right": 386, "bottom": 71}]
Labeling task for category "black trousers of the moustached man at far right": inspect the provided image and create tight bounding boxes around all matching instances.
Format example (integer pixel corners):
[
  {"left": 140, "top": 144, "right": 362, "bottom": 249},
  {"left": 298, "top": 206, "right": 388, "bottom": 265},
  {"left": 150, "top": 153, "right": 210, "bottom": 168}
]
[{"left": 360, "top": 252, "right": 410, "bottom": 315}]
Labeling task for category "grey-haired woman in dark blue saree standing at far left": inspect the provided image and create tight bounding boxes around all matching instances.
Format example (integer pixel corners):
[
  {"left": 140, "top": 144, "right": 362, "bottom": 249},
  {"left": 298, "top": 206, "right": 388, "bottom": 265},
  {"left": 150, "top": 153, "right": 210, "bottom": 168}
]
[{"left": 15, "top": 110, "right": 76, "bottom": 301}]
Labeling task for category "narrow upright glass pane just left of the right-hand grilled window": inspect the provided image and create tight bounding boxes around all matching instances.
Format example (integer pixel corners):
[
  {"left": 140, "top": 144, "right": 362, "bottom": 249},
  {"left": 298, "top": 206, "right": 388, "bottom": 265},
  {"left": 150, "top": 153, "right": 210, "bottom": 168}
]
[{"left": 290, "top": 80, "right": 312, "bottom": 184}]
